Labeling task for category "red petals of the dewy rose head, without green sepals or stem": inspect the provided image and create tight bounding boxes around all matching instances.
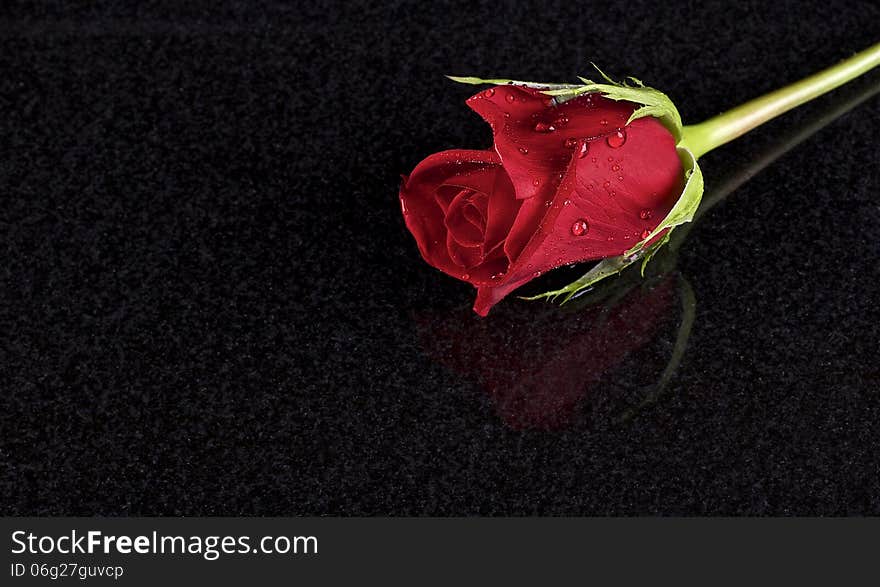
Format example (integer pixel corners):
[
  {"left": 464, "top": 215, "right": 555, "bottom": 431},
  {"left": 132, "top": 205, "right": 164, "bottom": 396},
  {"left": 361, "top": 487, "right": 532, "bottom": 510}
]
[{"left": 400, "top": 85, "right": 685, "bottom": 316}]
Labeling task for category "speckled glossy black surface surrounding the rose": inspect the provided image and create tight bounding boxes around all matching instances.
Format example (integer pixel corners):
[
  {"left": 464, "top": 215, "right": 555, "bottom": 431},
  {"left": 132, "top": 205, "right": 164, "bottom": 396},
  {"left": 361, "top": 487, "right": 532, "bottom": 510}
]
[{"left": 0, "top": 1, "right": 880, "bottom": 515}]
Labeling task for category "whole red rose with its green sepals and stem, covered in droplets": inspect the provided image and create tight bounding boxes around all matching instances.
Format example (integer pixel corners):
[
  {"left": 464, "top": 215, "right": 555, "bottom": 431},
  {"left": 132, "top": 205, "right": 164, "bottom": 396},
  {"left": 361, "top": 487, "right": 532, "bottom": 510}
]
[{"left": 400, "top": 44, "right": 880, "bottom": 316}]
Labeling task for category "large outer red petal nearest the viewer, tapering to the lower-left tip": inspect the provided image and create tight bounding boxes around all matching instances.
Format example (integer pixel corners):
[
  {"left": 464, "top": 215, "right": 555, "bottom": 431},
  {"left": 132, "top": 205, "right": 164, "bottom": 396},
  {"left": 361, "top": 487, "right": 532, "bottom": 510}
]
[{"left": 474, "top": 117, "right": 684, "bottom": 316}]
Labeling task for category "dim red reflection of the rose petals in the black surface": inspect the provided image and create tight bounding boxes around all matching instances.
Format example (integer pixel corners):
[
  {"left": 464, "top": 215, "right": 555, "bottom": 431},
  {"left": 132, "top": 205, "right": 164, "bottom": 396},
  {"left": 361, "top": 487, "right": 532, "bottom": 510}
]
[{"left": 417, "top": 274, "right": 677, "bottom": 430}]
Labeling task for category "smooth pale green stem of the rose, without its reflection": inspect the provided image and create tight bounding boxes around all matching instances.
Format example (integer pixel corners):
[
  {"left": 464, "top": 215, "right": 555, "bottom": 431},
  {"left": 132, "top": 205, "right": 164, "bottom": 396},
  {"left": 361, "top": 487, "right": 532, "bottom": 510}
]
[{"left": 682, "top": 43, "right": 880, "bottom": 157}]
